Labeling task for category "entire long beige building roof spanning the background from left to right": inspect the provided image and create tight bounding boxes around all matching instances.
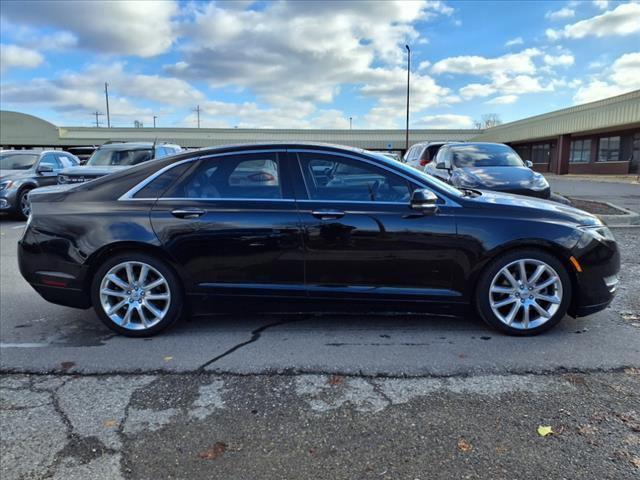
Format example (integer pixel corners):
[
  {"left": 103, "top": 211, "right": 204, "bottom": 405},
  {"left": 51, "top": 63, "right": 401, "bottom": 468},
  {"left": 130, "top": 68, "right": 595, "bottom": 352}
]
[{"left": 0, "top": 90, "right": 640, "bottom": 150}]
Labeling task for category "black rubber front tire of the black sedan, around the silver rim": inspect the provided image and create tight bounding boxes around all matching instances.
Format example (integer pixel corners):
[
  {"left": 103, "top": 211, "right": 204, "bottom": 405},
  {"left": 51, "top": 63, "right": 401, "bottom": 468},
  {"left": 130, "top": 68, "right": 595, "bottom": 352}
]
[{"left": 475, "top": 248, "right": 572, "bottom": 336}]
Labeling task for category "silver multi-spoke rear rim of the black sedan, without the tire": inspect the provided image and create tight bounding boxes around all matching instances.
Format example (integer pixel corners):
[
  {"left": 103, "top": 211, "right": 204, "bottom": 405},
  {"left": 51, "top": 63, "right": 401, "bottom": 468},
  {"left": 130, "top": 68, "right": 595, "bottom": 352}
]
[{"left": 100, "top": 262, "right": 171, "bottom": 330}]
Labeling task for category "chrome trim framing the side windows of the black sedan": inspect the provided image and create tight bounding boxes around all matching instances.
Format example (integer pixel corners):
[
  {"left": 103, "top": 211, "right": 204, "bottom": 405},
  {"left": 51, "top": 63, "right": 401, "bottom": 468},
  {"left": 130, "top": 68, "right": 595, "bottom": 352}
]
[{"left": 118, "top": 148, "right": 461, "bottom": 207}]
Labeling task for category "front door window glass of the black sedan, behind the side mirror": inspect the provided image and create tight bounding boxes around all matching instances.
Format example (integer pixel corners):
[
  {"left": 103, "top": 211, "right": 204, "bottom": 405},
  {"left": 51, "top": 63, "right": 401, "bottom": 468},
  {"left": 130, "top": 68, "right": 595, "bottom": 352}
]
[{"left": 300, "top": 153, "right": 411, "bottom": 202}]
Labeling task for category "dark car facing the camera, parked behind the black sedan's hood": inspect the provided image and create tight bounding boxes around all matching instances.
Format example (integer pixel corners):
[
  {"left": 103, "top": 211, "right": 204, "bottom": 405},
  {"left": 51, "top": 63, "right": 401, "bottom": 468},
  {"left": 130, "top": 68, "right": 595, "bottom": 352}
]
[{"left": 424, "top": 143, "right": 551, "bottom": 199}]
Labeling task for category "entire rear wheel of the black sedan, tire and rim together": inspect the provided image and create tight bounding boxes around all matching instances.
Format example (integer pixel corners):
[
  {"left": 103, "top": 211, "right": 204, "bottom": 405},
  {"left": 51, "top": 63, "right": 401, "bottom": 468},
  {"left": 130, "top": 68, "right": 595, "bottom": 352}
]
[{"left": 91, "top": 253, "right": 183, "bottom": 337}]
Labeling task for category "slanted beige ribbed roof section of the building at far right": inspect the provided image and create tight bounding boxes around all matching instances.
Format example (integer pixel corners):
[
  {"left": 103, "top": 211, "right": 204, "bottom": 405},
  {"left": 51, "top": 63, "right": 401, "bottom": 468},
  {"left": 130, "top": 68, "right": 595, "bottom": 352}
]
[{"left": 471, "top": 90, "right": 640, "bottom": 143}]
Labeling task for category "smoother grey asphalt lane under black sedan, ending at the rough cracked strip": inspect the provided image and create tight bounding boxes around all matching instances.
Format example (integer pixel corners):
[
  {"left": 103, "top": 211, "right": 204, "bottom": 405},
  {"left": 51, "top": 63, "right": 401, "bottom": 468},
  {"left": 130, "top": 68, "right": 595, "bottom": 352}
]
[{"left": 0, "top": 219, "right": 640, "bottom": 376}]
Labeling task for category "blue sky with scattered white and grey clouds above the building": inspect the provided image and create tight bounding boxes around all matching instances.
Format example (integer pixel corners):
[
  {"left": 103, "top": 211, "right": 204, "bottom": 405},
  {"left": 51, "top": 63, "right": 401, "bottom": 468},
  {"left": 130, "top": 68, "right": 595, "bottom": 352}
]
[{"left": 0, "top": 0, "right": 640, "bottom": 129}]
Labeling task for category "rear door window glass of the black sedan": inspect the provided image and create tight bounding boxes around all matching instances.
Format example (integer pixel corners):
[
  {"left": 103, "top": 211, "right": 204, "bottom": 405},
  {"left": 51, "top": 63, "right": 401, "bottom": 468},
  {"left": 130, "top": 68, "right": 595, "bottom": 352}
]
[{"left": 164, "top": 153, "right": 282, "bottom": 199}]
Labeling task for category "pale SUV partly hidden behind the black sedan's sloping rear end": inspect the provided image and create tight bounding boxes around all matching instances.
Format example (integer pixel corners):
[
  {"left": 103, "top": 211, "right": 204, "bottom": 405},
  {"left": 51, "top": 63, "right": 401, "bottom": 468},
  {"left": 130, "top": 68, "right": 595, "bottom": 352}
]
[{"left": 58, "top": 142, "right": 182, "bottom": 184}]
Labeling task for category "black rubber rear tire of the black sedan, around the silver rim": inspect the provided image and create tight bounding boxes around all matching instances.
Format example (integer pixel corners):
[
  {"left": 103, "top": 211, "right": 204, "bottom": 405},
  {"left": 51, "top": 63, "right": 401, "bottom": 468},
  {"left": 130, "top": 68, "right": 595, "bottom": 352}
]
[{"left": 91, "top": 252, "right": 184, "bottom": 337}]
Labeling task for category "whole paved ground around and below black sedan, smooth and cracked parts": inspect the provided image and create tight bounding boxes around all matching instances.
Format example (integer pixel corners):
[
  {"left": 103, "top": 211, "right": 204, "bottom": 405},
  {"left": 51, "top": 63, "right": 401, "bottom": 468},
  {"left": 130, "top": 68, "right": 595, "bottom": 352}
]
[{"left": 0, "top": 220, "right": 640, "bottom": 480}]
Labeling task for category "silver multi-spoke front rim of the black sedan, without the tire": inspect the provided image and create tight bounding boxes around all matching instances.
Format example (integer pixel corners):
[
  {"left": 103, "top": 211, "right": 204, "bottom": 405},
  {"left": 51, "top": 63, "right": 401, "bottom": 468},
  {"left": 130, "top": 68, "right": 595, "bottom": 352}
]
[{"left": 489, "top": 258, "right": 562, "bottom": 330}]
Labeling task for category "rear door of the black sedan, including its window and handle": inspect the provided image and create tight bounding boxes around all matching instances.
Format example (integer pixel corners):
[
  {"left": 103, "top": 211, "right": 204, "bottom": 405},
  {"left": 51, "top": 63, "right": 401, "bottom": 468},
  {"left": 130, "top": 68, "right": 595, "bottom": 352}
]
[{"left": 151, "top": 150, "right": 305, "bottom": 296}]
